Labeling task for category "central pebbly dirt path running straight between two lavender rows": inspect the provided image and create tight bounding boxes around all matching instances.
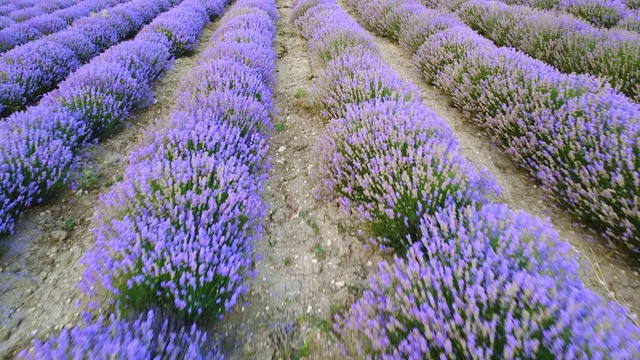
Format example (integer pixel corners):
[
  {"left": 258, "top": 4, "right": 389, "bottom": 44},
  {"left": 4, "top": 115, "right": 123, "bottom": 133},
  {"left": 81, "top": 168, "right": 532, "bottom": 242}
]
[{"left": 214, "top": 0, "right": 380, "bottom": 359}]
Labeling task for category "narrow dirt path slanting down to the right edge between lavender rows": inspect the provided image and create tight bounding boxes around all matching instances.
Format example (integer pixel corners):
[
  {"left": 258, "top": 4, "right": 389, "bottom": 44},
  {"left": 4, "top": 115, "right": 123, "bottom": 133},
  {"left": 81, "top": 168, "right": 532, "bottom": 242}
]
[{"left": 338, "top": 1, "right": 640, "bottom": 320}]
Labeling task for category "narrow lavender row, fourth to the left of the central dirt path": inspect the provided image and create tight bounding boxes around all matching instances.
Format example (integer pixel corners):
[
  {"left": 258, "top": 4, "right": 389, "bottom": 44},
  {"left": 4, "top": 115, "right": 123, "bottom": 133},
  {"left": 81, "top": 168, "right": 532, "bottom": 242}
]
[{"left": 0, "top": 0, "right": 126, "bottom": 53}]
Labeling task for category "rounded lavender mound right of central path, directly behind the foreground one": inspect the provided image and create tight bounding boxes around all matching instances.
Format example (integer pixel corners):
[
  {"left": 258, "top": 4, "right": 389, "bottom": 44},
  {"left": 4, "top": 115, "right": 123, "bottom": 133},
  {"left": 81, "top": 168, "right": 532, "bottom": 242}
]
[{"left": 321, "top": 101, "right": 498, "bottom": 252}]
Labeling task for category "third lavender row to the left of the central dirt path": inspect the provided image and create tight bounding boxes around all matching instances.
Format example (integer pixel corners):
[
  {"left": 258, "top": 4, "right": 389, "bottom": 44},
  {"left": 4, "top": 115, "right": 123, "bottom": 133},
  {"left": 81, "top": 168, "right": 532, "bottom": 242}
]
[{"left": 0, "top": 0, "right": 182, "bottom": 116}]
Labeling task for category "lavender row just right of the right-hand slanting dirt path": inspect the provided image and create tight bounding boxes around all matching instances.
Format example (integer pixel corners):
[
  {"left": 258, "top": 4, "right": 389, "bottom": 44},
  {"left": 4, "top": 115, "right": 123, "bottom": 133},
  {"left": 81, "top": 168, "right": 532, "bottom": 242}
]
[{"left": 355, "top": 0, "right": 640, "bottom": 257}]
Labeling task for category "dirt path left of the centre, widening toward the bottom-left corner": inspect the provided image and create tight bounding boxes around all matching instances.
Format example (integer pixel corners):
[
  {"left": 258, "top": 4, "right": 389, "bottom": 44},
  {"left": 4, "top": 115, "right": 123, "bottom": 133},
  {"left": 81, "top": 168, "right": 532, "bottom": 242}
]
[{"left": 0, "top": 22, "right": 222, "bottom": 359}]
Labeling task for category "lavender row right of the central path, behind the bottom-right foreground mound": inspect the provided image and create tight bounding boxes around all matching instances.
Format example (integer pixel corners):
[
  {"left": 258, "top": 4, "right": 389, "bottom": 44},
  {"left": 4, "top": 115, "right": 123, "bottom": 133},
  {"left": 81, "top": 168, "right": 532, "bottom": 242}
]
[{"left": 294, "top": 2, "right": 499, "bottom": 252}]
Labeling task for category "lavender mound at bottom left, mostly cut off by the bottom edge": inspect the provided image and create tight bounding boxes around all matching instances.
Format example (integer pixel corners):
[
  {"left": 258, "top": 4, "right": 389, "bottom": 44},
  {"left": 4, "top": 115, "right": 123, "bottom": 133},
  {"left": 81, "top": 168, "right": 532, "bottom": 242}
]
[{"left": 18, "top": 310, "right": 224, "bottom": 360}]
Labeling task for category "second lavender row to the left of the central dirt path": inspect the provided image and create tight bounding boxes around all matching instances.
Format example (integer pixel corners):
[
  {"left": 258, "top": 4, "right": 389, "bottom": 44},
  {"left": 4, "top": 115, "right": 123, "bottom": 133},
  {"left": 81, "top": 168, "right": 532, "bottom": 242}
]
[{"left": 0, "top": 0, "right": 222, "bottom": 233}]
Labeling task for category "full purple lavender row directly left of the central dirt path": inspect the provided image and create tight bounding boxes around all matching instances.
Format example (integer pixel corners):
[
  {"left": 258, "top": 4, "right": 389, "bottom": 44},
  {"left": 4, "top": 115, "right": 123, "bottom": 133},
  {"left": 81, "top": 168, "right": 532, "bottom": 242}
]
[{"left": 22, "top": 0, "right": 277, "bottom": 359}]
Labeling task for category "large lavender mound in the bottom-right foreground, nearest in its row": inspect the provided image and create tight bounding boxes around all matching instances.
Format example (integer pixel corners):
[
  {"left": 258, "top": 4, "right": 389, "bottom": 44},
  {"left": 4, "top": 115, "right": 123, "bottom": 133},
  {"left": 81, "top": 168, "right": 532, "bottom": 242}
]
[{"left": 336, "top": 205, "right": 640, "bottom": 359}]
